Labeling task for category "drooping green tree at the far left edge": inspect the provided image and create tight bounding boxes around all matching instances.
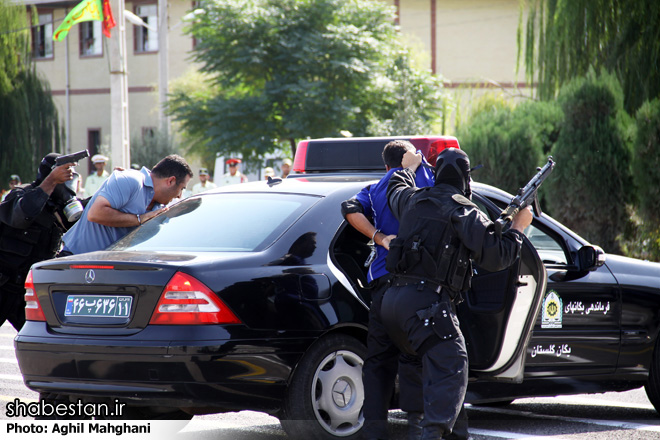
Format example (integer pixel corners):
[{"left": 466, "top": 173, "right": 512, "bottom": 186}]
[{"left": 0, "top": 0, "right": 60, "bottom": 183}]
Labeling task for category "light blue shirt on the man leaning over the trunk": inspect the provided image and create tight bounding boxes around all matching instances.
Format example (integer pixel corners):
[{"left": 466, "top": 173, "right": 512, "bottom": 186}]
[{"left": 62, "top": 167, "right": 163, "bottom": 254}]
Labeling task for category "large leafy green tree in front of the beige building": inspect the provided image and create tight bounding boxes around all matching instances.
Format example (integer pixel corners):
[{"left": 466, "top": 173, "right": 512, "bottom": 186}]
[{"left": 170, "top": 0, "right": 442, "bottom": 159}]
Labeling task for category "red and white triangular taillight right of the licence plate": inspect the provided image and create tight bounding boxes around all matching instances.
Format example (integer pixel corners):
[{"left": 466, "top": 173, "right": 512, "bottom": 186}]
[{"left": 149, "top": 272, "right": 241, "bottom": 325}]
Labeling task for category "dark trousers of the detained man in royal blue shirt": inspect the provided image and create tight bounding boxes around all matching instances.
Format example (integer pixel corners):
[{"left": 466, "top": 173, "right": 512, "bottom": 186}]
[{"left": 362, "top": 277, "right": 423, "bottom": 439}]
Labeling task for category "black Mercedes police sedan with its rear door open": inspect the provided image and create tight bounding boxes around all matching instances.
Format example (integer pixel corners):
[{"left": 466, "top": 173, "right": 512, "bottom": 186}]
[{"left": 15, "top": 136, "right": 660, "bottom": 439}]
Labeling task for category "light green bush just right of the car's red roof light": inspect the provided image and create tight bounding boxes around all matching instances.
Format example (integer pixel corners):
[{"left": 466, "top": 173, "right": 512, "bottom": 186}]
[{"left": 457, "top": 96, "right": 563, "bottom": 197}]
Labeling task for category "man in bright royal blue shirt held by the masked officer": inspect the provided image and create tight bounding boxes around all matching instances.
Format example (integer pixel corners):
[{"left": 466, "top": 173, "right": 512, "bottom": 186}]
[{"left": 342, "top": 140, "right": 434, "bottom": 439}]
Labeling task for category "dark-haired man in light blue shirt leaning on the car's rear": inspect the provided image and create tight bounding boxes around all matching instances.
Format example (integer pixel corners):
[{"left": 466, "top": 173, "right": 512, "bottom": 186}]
[{"left": 60, "top": 154, "right": 193, "bottom": 256}]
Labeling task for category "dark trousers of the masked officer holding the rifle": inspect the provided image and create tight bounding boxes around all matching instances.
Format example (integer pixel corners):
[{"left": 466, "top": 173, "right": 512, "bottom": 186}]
[{"left": 381, "top": 284, "right": 468, "bottom": 439}]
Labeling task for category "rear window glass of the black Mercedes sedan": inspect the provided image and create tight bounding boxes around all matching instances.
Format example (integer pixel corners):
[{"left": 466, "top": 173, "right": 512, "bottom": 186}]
[{"left": 108, "top": 193, "right": 318, "bottom": 252}]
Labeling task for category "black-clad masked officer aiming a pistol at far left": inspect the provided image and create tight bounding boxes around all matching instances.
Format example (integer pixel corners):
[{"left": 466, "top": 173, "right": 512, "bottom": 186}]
[{"left": 0, "top": 153, "right": 75, "bottom": 330}]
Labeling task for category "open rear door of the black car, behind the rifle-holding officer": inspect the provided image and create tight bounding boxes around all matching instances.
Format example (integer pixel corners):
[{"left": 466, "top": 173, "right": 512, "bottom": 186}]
[{"left": 457, "top": 195, "right": 547, "bottom": 383}]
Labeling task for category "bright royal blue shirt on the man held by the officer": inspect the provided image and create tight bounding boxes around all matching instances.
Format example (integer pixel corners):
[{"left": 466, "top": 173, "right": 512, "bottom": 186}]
[{"left": 355, "top": 165, "right": 434, "bottom": 282}]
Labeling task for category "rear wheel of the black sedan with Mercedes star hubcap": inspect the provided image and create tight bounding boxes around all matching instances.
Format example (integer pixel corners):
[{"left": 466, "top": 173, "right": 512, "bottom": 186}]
[{"left": 280, "top": 334, "right": 367, "bottom": 440}]
